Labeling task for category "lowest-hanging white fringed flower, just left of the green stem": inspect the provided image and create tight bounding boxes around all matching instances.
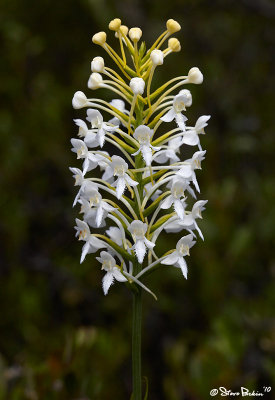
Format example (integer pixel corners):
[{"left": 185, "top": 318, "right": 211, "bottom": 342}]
[{"left": 96, "top": 251, "right": 127, "bottom": 295}]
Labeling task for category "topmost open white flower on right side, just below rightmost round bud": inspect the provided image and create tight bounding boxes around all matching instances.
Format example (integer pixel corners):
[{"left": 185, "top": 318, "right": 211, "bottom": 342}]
[{"left": 160, "top": 89, "right": 192, "bottom": 131}]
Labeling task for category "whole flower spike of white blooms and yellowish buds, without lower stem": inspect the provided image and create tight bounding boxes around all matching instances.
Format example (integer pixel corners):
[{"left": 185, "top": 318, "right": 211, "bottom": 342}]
[{"left": 70, "top": 18, "right": 210, "bottom": 296}]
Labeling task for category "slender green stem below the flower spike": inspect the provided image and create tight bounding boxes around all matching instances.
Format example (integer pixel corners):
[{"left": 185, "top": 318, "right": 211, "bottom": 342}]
[{"left": 132, "top": 264, "right": 142, "bottom": 400}]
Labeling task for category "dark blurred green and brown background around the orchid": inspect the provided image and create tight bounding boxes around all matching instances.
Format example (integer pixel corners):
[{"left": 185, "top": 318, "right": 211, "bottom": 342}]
[{"left": 0, "top": 0, "right": 275, "bottom": 400}]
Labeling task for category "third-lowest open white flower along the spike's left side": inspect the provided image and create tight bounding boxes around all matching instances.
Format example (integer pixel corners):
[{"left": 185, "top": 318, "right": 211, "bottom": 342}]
[{"left": 80, "top": 185, "right": 114, "bottom": 227}]
